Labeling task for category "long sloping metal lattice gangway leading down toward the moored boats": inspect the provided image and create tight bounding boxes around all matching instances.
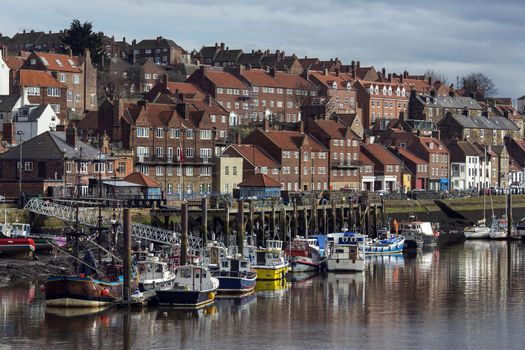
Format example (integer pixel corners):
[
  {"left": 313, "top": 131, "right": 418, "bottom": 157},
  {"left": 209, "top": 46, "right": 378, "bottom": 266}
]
[{"left": 24, "top": 198, "right": 202, "bottom": 255}]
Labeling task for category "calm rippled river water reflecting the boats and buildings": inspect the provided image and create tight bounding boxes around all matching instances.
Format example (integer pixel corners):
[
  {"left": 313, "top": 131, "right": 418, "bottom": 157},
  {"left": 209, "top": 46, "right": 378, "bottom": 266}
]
[{"left": 0, "top": 241, "right": 525, "bottom": 350}]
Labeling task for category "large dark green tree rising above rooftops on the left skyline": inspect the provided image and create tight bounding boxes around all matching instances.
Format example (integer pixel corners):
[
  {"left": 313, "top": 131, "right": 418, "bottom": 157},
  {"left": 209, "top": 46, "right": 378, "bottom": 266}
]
[{"left": 60, "top": 19, "right": 104, "bottom": 64}]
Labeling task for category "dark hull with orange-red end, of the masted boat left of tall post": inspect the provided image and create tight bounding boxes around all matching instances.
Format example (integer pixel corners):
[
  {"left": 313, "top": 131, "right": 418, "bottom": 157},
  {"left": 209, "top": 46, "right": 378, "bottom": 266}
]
[{"left": 44, "top": 275, "right": 122, "bottom": 308}]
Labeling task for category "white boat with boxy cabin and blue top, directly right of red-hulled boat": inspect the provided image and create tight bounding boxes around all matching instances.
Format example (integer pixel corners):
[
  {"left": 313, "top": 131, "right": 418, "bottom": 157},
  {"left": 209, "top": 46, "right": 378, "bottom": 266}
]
[{"left": 327, "top": 232, "right": 367, "bottom": 271}]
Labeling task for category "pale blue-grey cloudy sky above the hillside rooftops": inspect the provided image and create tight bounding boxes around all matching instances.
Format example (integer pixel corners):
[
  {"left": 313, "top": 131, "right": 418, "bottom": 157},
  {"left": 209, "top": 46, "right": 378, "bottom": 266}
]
[{"left": 0, "top": 0, "right": 525, "bottom": 98}]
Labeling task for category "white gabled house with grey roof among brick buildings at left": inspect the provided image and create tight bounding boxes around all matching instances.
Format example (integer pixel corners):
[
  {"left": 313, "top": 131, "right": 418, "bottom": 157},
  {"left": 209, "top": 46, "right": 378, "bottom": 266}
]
[{"left": 14, "top": 105, "right": 60, "bottom": 142}]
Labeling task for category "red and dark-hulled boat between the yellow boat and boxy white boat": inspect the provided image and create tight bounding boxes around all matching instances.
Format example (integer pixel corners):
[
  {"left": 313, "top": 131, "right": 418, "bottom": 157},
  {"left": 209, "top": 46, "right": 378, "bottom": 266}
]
[{"left": 285, "top": 237, "right": 323, "bottom": 273}]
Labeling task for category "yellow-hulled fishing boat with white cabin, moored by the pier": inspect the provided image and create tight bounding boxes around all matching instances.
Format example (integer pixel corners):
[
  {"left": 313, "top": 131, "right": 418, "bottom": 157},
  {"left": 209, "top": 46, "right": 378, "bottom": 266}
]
[{"left": 252, "top": 239, "right": 289, "bottom": 281}]
